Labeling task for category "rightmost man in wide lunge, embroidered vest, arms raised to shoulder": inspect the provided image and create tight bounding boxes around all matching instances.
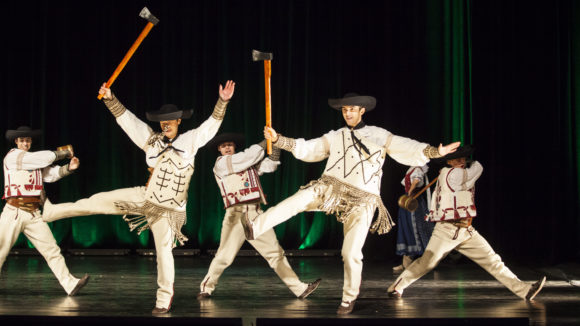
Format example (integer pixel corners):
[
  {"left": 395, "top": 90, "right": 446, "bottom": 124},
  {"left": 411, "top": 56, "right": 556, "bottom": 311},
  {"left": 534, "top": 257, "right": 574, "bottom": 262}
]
[{"left": 387, "top": 145, "right": 546, "bottom": 300}]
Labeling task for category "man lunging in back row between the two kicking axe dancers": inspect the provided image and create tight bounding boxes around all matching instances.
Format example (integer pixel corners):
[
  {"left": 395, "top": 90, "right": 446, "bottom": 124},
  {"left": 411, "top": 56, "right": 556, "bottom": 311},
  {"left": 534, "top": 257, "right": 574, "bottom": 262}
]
[{"left": 197, "top": 133, "right": 321, "bottom": 299}]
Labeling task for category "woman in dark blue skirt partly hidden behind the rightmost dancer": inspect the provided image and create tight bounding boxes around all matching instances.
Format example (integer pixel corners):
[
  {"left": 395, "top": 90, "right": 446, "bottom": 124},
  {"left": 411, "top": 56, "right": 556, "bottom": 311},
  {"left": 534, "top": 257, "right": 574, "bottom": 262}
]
[{"left": 393, "top": 165, "right": 434, "bottom": 273}]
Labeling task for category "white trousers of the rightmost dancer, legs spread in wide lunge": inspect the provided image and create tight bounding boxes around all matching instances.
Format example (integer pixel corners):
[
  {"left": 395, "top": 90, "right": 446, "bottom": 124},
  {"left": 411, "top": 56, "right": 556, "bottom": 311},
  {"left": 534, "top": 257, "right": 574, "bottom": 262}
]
[{"left": 388, "top": 222, "right": 531, "bottom": 298}]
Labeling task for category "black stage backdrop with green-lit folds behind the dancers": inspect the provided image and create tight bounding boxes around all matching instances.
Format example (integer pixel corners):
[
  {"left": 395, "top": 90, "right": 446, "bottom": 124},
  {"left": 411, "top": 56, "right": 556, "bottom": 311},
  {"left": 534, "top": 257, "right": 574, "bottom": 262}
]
[{"left": 0, "top": 0, "right": 580, "bottom": 262}]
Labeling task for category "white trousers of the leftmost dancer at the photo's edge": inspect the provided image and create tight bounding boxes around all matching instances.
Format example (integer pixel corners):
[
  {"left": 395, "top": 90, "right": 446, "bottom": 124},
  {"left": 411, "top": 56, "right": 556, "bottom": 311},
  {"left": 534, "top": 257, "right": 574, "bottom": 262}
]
[{"left": 0, "top": 204, "right": 79, "bottom": 294}]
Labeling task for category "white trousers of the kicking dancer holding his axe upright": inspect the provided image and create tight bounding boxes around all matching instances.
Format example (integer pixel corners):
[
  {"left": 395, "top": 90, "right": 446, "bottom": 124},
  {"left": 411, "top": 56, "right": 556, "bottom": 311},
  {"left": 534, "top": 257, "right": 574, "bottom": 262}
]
[{"left": 253, "top": 185, "right": 376, "bottom": 302}]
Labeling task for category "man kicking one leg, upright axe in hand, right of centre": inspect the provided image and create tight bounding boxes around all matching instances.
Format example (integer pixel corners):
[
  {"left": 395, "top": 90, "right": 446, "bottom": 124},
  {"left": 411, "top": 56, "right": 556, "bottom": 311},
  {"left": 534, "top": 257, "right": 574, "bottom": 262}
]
[{"left": 242, "top": 93, "right": 459, "bottom": 314}]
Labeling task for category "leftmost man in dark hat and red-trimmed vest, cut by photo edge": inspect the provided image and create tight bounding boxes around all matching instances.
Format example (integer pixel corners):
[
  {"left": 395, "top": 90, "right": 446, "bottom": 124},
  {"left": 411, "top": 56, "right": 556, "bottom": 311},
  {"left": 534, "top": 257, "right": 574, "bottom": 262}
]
[{"left": 0, "top": 126, "right": 89, "bottom": 296}]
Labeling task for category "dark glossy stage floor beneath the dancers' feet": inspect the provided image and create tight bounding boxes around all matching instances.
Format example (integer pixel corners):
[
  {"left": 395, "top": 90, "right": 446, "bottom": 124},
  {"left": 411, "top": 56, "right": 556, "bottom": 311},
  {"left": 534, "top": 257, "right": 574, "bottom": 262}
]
[{"left": 0, "top": 255, "right": 580, "bottom": 326}]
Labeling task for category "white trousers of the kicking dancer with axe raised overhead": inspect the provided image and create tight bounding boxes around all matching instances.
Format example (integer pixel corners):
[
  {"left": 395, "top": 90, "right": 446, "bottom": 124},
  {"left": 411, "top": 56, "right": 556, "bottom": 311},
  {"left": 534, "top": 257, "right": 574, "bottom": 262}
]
[{"left": 42, "top": 187, "right": 175, "bottom": 309}]
